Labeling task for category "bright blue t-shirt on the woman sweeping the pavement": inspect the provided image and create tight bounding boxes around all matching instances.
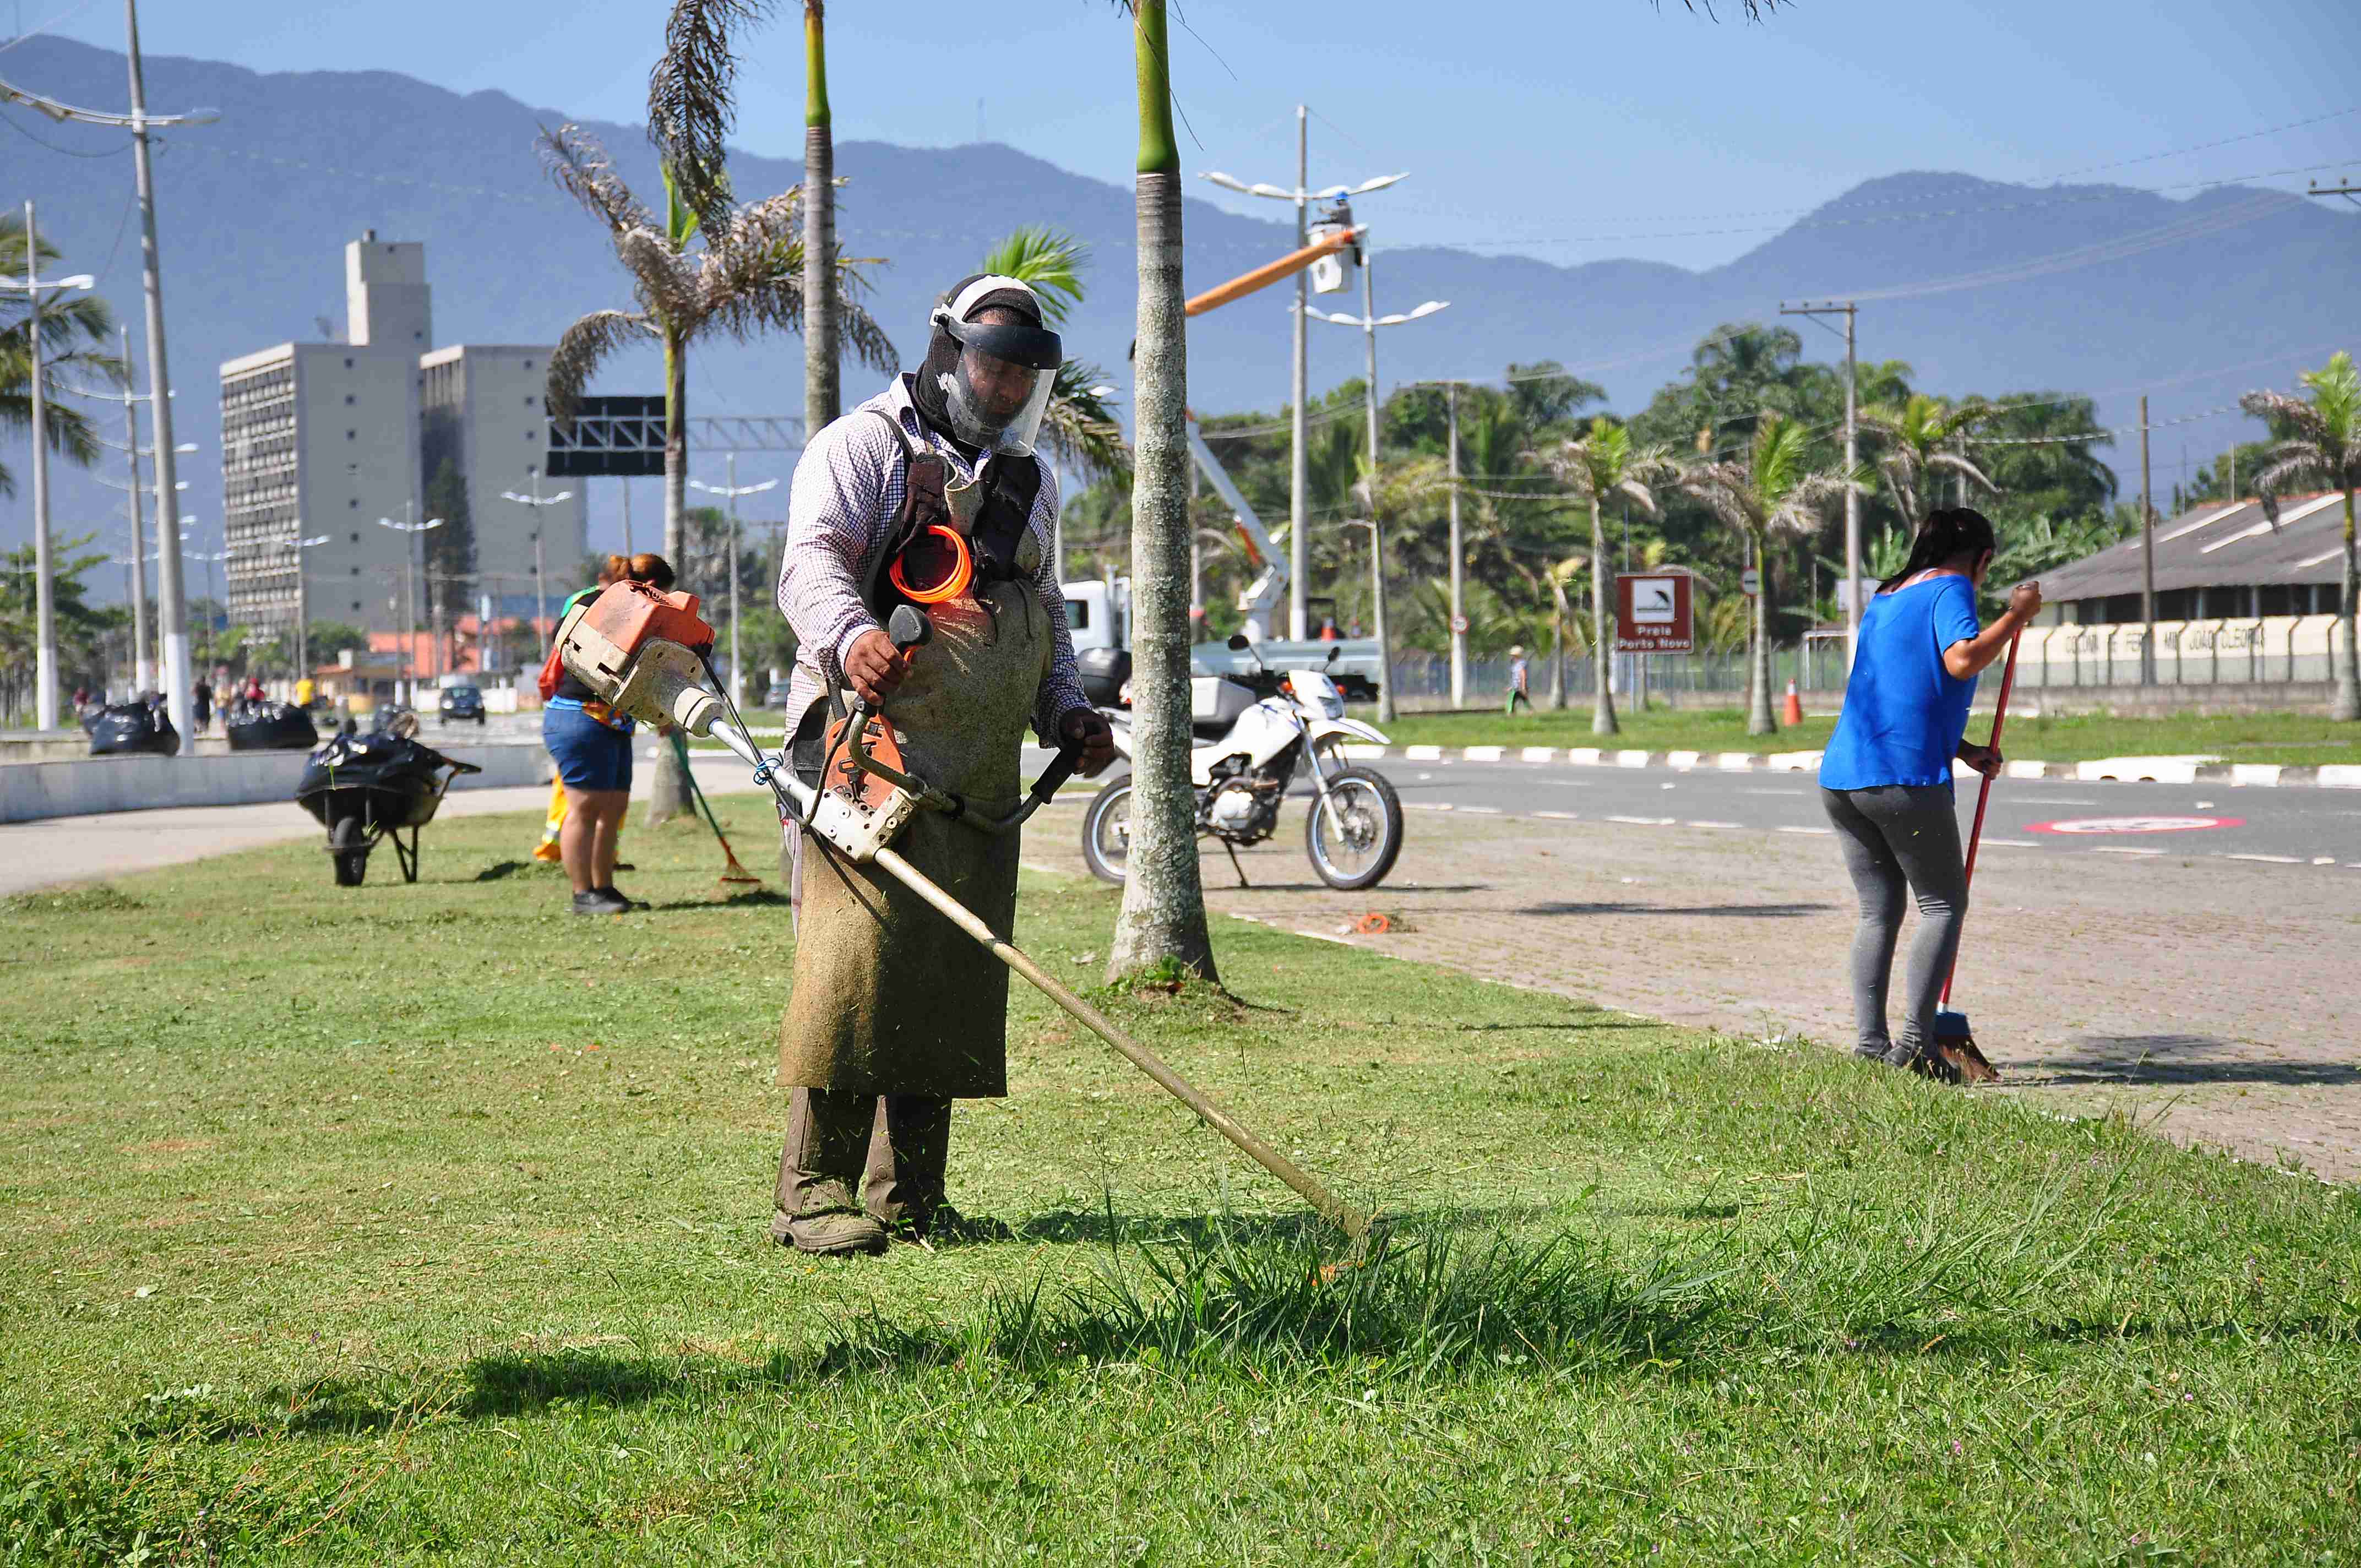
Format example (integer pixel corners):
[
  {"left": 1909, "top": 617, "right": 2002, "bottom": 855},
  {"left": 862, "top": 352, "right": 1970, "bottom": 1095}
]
[{"left": 1820, "top": 574, "right": 1983, "bottom": 789}]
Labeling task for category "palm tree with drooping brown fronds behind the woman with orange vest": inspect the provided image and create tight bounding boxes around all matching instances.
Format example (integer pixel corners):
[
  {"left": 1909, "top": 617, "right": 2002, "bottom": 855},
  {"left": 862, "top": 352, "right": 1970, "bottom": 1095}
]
[{"left": 541, "top": 125, "right": 895, "bottom": 824}]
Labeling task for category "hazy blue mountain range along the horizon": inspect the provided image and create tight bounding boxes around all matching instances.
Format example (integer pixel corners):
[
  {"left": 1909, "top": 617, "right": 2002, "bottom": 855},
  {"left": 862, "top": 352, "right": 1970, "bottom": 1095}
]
[{"left": 0, "top": 38, "right": 2361, "bottom": 581}]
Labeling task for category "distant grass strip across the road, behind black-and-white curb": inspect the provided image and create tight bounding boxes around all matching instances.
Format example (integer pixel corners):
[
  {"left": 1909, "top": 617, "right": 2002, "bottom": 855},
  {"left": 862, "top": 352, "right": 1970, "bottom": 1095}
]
[{"left": 1355, "top": 704, "right": 2361, "bottom": 765}]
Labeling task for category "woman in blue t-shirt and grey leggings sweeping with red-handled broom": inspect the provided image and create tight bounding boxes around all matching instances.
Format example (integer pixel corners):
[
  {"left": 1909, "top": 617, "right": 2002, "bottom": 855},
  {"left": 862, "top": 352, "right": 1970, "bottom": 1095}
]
[{"left": 1820, "top": 505, "right": 2042, "bottom": 1068}]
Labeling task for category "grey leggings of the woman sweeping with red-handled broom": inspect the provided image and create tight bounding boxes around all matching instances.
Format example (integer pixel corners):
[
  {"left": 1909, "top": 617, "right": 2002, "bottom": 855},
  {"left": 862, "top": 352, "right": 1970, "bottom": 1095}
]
[{"left": 1820, "top": 784, "right": 1967, "bottom": 1055}]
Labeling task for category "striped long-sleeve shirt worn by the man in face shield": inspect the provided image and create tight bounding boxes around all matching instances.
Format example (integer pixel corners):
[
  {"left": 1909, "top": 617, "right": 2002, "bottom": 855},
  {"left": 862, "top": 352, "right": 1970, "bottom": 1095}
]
[{"left": 779, "top": 375, "right": 1091, "bottom": 746}]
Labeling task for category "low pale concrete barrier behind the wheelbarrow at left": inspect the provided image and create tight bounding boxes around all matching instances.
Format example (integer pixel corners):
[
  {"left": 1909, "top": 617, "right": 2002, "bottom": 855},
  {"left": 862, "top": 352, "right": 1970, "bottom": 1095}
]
[{"left": 0, "top": 744, "right": 550, "bottom": 822}]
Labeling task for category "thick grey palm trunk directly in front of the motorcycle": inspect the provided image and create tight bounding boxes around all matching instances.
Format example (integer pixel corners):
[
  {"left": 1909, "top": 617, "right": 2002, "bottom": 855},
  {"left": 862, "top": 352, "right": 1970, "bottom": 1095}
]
[{"left": 1107, "top": 0, "right": 1216, "bottom": 982}]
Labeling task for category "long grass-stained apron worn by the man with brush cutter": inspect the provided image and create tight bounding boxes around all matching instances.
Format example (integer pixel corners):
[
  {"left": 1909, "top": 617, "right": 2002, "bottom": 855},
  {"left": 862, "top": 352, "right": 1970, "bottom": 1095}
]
[{"left": 779, "top": 559, "right": 1051, "bottom": 1098}]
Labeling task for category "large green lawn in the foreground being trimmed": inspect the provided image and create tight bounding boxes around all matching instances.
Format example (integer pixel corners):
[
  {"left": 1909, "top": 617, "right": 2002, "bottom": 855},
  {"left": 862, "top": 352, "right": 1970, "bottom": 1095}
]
[{"left": 0, "top": 798, "right": 2361, "bottom": 1563}]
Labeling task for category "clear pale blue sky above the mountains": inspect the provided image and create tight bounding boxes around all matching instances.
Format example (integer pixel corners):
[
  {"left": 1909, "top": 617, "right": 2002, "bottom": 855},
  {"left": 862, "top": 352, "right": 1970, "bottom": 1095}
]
[{"left": 18, "top": 0, "right": 2361, "bottom": 267}]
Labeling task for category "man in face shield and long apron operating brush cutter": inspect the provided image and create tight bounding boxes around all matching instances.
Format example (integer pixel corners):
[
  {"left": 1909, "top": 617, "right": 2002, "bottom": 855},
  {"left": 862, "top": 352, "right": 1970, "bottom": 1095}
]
[{"left": 772, "top": 276, "right": 1114, "bottom": 1254}]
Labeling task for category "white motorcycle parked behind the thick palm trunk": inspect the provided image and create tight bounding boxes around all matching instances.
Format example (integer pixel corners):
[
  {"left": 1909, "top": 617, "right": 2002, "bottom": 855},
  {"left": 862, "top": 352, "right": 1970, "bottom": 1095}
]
[{"left": 1081, "top": 638, "right": 1402, "bottom": 892}]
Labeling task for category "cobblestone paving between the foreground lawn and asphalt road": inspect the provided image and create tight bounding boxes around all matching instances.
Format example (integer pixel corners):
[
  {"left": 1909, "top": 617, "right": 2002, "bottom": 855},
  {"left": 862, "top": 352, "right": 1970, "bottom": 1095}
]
[{"left": 1025, "top": 812, "right": 2361, "bottom": 1181}]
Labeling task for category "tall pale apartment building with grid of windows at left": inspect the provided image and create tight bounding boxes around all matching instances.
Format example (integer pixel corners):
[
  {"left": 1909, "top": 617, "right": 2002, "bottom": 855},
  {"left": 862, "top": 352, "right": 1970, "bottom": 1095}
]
[{"left": 222, "top": 229, "right": 588, "bottom": 630}]
